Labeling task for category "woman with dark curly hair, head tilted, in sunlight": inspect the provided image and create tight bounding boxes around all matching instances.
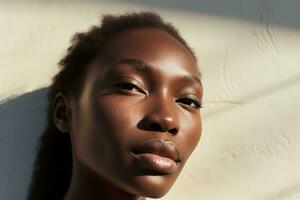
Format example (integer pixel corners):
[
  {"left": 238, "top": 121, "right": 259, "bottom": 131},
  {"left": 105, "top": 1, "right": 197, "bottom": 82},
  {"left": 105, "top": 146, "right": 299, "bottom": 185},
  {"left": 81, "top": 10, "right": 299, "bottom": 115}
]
[{"left": 28, "top": 12, "right": 203, "bottom": 200}]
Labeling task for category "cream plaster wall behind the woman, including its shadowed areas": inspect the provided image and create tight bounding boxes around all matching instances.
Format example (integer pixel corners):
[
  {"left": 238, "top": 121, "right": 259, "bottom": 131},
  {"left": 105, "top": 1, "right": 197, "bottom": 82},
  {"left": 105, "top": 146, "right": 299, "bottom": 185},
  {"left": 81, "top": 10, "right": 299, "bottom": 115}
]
[{"left": 0, "top": 0, "right": 300, "bottom": 200}]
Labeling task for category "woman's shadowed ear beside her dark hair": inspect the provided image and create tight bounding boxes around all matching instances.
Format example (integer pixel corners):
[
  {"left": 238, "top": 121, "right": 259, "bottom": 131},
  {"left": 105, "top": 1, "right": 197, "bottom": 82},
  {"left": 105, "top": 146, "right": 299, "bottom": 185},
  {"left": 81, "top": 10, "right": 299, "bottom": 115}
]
[{"left": 52, "top": 92, "right": 71, "bottom": 133}]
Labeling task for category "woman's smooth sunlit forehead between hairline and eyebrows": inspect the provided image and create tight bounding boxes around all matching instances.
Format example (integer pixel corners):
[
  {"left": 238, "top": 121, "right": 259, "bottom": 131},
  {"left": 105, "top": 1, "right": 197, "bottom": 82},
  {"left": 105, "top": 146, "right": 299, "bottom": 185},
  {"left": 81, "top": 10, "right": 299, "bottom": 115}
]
[{"left": 95, "top": 28, "right": 199, "bottom": 75}]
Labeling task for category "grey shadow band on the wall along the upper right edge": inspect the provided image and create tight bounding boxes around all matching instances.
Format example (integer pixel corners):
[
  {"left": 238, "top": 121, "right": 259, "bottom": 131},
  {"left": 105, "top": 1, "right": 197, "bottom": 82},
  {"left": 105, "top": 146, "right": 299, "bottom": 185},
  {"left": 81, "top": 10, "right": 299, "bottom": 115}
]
[{"left": 119, "top": 0, "right": 300, "bottom": 29}]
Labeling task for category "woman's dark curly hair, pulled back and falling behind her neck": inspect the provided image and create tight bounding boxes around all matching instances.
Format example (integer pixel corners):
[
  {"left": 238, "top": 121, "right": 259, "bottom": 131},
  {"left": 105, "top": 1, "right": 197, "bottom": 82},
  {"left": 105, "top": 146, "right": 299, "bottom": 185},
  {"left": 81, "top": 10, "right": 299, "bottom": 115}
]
[{"left": 27, "top": 12, "right": 197, "bottom": 200}]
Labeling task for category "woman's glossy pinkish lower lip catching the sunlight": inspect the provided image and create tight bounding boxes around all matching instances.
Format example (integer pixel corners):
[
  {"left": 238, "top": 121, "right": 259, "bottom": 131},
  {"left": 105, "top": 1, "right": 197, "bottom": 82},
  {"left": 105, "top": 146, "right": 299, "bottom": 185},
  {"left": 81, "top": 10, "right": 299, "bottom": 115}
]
[{"left": 133, "top": 153, "right": 177, "bottom": 173}]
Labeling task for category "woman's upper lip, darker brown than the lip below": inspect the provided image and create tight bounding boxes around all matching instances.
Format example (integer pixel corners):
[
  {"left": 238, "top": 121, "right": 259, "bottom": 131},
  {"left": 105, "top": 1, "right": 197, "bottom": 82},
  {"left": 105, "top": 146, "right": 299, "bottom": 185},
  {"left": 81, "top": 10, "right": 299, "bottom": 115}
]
[{"left": 132, "top": 139, "right": 180, "bottom": 162}]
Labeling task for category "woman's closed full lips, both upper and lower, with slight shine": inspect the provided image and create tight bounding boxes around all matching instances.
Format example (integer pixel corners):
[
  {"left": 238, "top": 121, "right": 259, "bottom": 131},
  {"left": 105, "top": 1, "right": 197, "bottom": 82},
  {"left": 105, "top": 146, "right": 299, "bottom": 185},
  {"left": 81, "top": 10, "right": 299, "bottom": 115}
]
[{"left": 132, "top": 139, "right": 180, "bottom": 174}]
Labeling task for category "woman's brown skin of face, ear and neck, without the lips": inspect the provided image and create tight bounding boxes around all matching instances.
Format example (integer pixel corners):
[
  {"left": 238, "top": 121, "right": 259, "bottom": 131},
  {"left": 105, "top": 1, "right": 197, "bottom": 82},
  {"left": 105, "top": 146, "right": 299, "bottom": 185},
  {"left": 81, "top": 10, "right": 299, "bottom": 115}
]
[{"left": 53, "top": 28, "right": 203, "bottom": 200}]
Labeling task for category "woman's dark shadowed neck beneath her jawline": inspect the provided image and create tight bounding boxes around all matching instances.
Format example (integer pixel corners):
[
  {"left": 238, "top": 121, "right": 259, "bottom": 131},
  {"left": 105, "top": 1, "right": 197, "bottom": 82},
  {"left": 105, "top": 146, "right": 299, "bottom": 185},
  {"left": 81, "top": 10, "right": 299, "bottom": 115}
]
[{"left": 63, "top": 162, "right": 146, "bottom": 200}]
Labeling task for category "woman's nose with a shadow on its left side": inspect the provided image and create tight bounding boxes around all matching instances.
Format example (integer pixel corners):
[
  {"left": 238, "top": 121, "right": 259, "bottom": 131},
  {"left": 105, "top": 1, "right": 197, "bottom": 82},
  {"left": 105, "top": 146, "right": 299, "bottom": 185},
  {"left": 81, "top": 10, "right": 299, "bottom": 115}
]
[{"left": 138, "top": 99, "right": 179, "bottom": 135}]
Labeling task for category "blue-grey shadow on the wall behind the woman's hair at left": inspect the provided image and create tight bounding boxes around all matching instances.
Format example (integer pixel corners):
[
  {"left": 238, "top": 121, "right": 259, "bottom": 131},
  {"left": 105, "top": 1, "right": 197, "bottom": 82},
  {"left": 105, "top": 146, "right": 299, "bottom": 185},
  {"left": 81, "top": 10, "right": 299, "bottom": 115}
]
[{"left": 0, "top": 88, "right": 48, "bottom": 200}]
